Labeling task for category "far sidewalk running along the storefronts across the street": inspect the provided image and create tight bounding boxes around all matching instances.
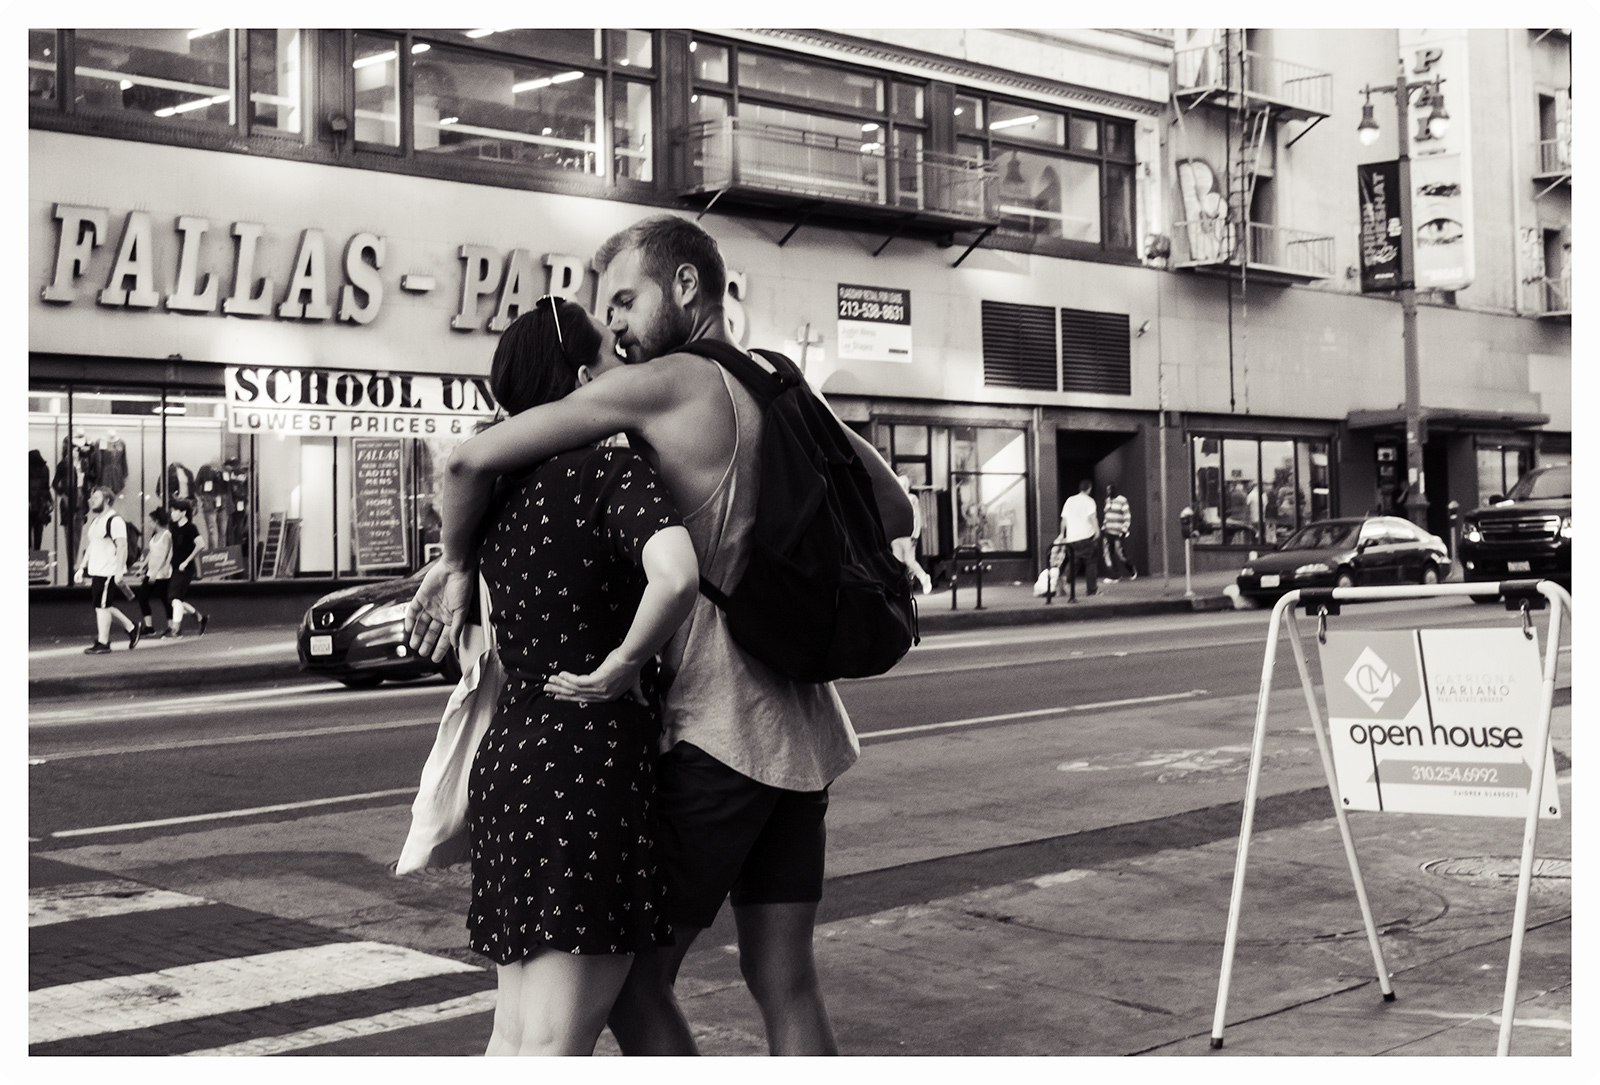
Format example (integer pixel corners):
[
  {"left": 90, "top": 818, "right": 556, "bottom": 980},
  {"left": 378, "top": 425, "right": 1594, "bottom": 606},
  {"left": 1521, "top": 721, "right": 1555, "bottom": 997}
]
[{"left": 27, "top": 573, "right": 1235, "bottom": 699}]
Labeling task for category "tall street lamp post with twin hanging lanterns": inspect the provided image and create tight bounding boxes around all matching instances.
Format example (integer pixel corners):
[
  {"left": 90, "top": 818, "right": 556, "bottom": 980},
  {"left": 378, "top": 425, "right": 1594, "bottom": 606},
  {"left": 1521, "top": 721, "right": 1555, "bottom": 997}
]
[{"left": 1355, "top": 59, "right": 1450, "bottom": 530}]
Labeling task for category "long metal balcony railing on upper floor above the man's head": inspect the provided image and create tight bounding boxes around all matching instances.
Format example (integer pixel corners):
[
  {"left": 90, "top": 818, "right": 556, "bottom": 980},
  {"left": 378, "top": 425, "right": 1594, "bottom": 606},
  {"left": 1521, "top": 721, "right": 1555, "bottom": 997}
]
[{"left": 677, "top": 117, "right": 997, "bottom": 222}]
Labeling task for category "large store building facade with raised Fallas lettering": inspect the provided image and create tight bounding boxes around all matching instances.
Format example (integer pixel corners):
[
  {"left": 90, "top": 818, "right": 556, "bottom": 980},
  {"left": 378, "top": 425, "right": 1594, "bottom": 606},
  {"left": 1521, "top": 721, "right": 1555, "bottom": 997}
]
[{"left": 29, "top": 29, "right": 1571, "bottom": 595}]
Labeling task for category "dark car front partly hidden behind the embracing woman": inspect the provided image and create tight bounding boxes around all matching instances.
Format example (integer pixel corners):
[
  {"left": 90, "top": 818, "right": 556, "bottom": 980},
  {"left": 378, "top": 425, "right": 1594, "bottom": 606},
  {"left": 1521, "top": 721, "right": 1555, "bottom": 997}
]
[{"left": 296, "top": 567, "right": 461, "bottom": 690}]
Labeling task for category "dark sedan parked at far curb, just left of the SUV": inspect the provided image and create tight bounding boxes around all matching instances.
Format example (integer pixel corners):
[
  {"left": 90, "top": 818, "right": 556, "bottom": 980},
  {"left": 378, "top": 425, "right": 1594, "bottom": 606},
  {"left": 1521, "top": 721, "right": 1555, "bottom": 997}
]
[{"left": 1238, "top": 517, "right": 1450, "bottom": 599}]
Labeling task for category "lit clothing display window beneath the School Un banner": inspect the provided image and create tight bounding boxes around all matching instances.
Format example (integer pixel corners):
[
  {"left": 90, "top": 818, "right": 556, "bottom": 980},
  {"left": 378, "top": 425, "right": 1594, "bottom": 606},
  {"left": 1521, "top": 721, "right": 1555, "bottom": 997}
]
[{"left": 27, "top": 381, "right": 493, "bottom": 586}]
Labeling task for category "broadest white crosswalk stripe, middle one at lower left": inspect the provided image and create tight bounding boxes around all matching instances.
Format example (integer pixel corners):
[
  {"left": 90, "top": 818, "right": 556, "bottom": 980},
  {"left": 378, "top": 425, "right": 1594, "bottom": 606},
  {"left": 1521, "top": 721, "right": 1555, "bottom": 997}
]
[{"left": 27, "top": 943, "right": 480, "bottom": 1045}]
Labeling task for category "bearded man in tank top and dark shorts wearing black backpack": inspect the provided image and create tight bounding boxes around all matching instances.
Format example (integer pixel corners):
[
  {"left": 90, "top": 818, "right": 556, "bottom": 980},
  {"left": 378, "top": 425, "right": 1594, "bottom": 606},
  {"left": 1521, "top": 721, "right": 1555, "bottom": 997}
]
[{"left": 406, "top": 214, "right": 914, "bottom": 1055}]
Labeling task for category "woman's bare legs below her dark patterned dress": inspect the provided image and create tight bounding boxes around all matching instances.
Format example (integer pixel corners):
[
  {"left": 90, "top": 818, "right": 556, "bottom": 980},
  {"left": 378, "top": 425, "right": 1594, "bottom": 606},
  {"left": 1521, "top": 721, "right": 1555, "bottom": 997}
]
[{"left": 485, "top": 951, "right": 634, "bottom": 1055}]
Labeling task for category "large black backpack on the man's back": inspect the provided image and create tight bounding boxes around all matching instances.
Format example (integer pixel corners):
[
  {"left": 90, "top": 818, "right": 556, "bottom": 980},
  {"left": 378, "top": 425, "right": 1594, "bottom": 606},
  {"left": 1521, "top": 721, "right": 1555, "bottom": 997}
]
[{"left": 680, "top": 339, "right": 920, "bottom": 682}]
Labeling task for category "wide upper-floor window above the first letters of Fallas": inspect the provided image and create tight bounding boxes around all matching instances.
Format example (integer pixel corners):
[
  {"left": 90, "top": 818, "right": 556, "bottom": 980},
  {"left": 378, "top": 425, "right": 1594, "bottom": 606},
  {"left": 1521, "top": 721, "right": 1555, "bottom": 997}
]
[{"left": 74, "top": 29, "right": 234, "bottom": 125}]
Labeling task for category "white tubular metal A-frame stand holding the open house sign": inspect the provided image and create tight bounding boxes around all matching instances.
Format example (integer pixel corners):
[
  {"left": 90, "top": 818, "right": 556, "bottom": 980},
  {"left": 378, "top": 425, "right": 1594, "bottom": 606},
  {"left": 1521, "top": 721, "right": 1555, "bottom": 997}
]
[{"left": 1211, "top": 579, "right": 1573, "bottom": 1056}]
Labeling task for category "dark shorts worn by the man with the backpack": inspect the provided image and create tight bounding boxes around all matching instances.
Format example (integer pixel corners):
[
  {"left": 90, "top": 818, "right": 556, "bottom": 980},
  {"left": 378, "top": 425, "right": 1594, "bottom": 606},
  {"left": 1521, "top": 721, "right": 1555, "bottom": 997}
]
[{"left": 656, "top": 743, "right": 827, "bottom": 928}]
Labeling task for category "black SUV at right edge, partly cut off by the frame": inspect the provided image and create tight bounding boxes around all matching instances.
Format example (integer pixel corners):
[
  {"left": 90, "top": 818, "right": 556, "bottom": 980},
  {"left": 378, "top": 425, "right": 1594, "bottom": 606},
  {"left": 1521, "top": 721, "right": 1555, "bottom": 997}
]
[{"left": 1461, "top": 464, "right": 1573, "bottom": 591}]
